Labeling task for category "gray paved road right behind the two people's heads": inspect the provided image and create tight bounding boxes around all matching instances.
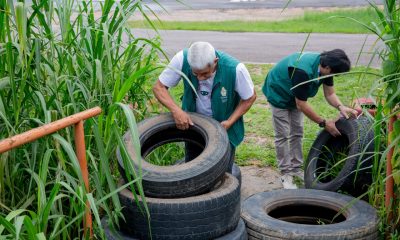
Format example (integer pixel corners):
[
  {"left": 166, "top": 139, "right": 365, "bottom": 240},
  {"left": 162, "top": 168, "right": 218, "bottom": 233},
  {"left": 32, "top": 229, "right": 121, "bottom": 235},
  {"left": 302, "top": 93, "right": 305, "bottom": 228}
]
[{"left": 133, "top": 29, "right": 379, "bottom": 67}]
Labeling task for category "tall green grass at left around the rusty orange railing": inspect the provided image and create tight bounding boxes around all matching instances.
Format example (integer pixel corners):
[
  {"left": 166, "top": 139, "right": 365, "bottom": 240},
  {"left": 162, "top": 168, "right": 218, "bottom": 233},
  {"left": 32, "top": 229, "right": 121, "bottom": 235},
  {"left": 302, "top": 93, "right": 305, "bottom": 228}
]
[{"left": 0, "top": 0, "right": 160, "bottom": 239}]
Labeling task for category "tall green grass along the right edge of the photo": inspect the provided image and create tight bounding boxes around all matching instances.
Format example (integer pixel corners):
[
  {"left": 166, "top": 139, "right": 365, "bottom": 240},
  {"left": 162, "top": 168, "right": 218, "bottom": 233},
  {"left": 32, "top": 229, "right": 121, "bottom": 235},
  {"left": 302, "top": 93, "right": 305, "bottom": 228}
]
[{"left": 338, "top": 0, "right": 400, "bottom": 239}]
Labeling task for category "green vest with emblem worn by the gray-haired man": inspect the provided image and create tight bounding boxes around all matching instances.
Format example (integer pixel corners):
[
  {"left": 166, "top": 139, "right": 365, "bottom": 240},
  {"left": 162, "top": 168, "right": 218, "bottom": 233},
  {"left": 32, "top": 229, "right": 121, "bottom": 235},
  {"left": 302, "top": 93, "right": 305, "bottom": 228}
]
[{"left": 182, "top": 49, "right": 244, "bottom": 147}]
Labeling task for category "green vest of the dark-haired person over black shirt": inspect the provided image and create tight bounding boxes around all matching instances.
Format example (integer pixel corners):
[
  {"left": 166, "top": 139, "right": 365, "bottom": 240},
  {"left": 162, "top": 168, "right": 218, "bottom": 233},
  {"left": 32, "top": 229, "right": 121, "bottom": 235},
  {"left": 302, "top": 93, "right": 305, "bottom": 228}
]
[{"left": 262, "top": 52, "right": 323, "bottom": 109}]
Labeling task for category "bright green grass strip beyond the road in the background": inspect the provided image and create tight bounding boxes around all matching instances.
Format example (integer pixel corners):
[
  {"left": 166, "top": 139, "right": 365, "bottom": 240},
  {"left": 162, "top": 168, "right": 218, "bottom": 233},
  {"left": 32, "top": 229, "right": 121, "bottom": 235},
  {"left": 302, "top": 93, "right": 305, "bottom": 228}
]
[{"left": 129, "top": 8, "right": 378, "bottom": 33}]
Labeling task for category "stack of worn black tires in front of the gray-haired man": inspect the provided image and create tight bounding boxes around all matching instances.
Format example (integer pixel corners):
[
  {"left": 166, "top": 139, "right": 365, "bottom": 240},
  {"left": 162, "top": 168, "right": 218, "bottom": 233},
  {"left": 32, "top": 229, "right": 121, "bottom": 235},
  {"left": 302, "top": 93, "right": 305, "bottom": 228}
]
[{"left": 103, "top": 113, "right": 247, "bottom": 240}]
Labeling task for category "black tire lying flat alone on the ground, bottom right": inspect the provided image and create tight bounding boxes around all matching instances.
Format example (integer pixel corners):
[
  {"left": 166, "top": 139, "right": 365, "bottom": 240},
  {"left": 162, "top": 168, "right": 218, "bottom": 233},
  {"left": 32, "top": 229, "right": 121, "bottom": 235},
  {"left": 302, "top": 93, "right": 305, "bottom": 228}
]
[{"left": 242, "top": 189, "right": 379, "bottom": 240}]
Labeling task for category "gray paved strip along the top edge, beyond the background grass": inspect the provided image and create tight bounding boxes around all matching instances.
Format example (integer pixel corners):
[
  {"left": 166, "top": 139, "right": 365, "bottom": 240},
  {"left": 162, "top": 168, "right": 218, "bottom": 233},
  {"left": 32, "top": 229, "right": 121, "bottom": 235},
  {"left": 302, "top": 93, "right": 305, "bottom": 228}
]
[{"left": 143, "top": 0, "right": 383, "bottom": 11}]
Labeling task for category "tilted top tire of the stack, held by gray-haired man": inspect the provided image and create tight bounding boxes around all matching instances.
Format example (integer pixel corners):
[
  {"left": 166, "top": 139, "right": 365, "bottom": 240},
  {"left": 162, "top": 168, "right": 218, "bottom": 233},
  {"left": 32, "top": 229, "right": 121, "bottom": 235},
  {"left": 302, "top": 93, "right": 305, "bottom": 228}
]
[{"left": 117, "top": 113, "right": 230, "bottom": 198}]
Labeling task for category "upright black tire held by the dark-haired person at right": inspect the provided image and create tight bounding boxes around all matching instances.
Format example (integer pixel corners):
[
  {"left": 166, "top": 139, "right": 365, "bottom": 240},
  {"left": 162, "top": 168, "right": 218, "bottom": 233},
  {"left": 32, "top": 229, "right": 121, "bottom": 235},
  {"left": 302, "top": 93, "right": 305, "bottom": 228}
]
[{"left": 304, "top": 117, "right": 374, "bottom": 196}]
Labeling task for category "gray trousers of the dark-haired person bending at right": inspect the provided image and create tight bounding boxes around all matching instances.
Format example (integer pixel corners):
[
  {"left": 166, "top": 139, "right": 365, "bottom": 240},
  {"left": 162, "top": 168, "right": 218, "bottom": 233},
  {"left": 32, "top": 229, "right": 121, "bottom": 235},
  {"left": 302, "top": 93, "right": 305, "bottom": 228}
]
[{"left": 270, "top": 105, "right": 304, "bottom": 174}]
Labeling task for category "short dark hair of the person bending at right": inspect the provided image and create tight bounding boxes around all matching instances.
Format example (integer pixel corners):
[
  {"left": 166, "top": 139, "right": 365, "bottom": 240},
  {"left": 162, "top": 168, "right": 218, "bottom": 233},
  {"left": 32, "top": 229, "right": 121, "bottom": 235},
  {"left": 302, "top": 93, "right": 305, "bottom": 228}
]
[{"left": 320, "top": 49, "right": 351, "bottom": 73}]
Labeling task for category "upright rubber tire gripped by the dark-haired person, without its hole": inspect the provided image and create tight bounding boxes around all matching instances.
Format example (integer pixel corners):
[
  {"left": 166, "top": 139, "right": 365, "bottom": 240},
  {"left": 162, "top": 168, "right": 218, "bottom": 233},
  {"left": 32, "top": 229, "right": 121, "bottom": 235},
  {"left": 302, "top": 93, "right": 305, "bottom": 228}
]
[{"left": 304, "top": 117, "right": 374, "bottom": 196}]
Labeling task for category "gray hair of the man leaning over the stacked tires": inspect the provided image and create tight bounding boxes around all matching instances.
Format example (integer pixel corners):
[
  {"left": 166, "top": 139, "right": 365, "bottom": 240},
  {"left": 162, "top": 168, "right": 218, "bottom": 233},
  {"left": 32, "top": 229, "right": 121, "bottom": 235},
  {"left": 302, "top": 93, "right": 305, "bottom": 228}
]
[{"left": 188, "top": 42, "right": 216, "bottom": 70}]
